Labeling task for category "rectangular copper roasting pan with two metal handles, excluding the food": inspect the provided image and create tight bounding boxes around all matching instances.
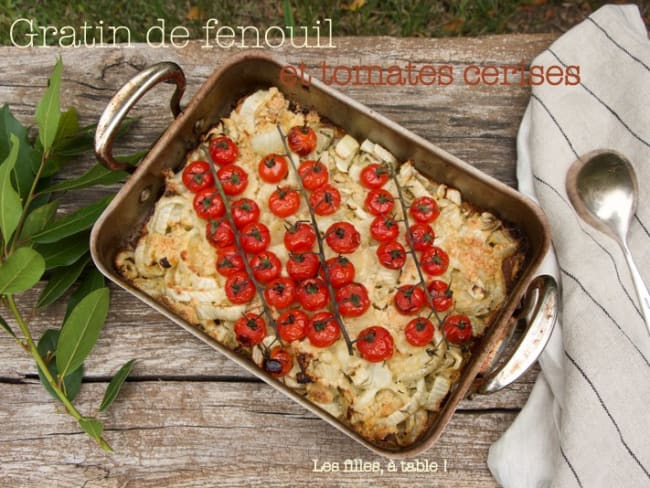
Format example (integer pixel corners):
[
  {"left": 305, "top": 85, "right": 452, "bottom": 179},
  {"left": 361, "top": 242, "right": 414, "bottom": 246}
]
[{"left": 91, "top": 51, "right": 559, "bottom": 457}]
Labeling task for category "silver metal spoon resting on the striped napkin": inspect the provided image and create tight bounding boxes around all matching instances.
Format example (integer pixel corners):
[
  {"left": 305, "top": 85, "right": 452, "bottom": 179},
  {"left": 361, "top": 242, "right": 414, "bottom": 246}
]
[{"left": 566, "top": 151, "right": 650, "bottom": 334}]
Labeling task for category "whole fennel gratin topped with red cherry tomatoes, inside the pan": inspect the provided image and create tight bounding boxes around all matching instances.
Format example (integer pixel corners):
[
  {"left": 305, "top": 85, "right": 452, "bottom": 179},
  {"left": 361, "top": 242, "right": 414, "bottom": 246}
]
[{"left": 115, "top": 88, "right": 524, "bottom": 446}]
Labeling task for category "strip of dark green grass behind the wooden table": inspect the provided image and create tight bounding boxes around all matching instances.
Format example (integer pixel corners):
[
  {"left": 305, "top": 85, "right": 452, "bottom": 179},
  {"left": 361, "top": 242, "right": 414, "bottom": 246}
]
[{"left": 0, "top": 0, "right": 650, "bottom": 45}]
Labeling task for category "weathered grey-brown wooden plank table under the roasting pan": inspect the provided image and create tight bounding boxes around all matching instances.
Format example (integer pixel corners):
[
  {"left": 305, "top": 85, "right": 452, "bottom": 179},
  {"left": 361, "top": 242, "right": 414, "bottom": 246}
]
[{"left": 0, "top": 35, "right": 554, "bottom": 487}]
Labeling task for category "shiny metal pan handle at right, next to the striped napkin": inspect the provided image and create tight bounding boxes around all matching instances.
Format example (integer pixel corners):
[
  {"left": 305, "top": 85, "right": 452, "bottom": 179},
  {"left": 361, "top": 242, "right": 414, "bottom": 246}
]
[{"left": 475, "top": 275, "right": 560, "bottom": 394}]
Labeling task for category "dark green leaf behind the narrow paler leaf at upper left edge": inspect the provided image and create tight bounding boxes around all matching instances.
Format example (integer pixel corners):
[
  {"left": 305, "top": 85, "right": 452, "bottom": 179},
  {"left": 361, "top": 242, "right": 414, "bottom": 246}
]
[{"left": 0, "top": 105, "right": 41, "bottom": 199}]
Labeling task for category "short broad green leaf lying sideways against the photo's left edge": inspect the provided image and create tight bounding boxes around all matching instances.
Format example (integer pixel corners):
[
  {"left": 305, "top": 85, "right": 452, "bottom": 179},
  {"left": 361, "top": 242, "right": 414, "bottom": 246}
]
[{"left": 0, "top": 247, "right": 45, "bottom": 295}]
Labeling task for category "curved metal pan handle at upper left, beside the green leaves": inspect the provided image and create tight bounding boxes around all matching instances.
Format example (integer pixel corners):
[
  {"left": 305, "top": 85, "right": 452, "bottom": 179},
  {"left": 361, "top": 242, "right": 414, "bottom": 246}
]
[{"left": 95, "top": 62, "right": 186, "bottom": 170}]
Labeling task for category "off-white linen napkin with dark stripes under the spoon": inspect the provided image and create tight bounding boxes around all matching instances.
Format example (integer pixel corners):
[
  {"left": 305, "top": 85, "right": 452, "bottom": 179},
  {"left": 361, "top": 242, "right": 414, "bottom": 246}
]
[{"left": 488, "top": 5, "right": 650, "bottom": 488}]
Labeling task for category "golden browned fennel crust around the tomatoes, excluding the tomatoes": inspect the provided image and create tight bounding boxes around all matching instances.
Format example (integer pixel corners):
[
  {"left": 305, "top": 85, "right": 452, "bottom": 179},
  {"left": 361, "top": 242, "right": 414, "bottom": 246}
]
[{"left": 115, "top": 88, "right": 522, "bottom": 445}]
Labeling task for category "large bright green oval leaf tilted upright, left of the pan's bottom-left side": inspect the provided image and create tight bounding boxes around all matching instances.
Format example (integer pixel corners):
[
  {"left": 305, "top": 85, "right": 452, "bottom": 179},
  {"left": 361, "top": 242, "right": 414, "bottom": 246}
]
[{"left": 56, "top": 288, "right": 109, "bottom": 376}]
